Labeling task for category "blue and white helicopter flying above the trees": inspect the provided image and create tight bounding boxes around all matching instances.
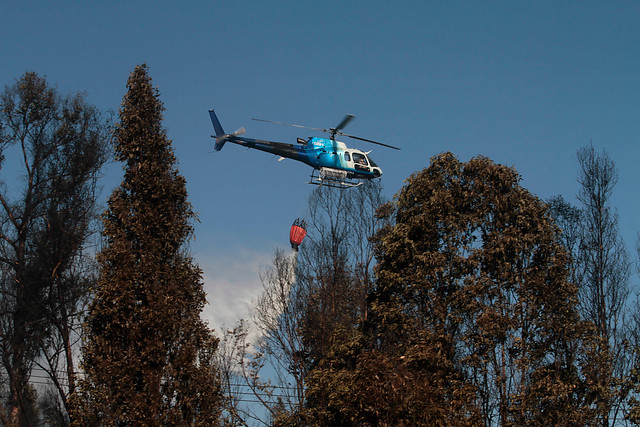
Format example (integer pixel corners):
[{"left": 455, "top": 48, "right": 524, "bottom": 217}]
[{"left": 209, "top": 109, "right": 399, "bottom": 189}]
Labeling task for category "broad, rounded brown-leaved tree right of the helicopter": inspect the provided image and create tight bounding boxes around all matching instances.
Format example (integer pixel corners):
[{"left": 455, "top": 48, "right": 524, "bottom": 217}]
[{"left": 308, "top": 153, "right": 594, "bottom": 425}]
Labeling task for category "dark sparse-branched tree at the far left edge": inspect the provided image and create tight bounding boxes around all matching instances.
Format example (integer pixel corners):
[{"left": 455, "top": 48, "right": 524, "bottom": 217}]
[{"left": 0, "top": 72, "right": 108, "bottom": 425}]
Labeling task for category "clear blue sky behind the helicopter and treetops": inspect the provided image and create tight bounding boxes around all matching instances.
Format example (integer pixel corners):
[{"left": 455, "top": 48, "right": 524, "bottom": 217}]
[{"left": 0, "top": 0, "right": 640, "bottom": 328}]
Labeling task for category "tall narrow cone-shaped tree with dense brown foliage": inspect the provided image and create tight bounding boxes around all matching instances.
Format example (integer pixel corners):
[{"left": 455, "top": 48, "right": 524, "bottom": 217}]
[{"left": 77, "top": 65, "right": 221, "bottom": 425}]
